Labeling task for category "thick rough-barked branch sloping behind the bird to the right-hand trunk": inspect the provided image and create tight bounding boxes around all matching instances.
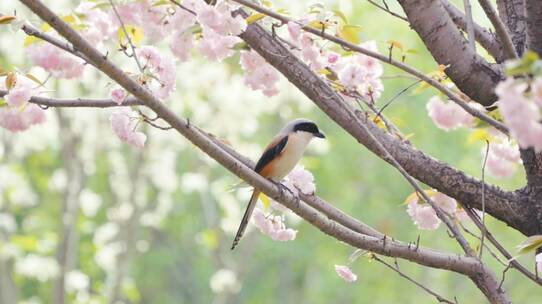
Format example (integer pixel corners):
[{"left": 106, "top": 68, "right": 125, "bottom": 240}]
[{"left": 235, "top": 5, "right": 527, "bottom": 240}]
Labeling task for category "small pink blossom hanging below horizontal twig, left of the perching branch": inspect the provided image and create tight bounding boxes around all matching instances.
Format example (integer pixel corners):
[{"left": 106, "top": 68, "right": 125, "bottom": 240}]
[{"left": 110, "top": 108, "right": 147, "bottom": 148}]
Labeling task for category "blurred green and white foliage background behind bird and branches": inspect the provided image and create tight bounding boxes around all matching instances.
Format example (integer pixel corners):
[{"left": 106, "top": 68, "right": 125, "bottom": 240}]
[{"left": 0, "top": 0, "right": 542, "bottom": 303}]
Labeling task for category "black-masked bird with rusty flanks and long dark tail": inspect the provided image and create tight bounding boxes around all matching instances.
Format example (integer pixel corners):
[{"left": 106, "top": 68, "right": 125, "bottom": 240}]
[{"left": 231, "top": 118, "right": 326, "bottom": 250}]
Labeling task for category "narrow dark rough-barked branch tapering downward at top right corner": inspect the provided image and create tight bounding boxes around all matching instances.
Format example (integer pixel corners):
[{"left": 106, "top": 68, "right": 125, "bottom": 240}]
[{"left": 497, "top": 0, "right": 527, "bottom": 56}]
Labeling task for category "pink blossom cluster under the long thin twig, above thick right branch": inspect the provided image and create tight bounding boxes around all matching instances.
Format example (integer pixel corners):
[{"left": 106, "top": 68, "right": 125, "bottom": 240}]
[{"left": 427, "top": 96, "right": 475, "bottom": 131}]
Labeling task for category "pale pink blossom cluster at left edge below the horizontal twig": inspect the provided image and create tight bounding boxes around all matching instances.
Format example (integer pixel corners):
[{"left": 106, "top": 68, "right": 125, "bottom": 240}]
[{"left": 0, "top": 104, "right": 46, "bottom": 132}]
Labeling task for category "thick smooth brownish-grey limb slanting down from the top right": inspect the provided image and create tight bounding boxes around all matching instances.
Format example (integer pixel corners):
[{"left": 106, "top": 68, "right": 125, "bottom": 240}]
[{"left": 399, "top": 0, "right": 504, "bottom": 106}]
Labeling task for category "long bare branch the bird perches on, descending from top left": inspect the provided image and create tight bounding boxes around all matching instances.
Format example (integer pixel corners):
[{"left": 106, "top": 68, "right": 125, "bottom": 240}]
[{"left": 17, "top": 0, "right": 489, "bottom": 277}]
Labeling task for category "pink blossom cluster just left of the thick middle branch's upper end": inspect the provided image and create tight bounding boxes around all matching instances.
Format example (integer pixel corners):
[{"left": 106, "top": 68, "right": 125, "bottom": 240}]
[{"left": 198, "top": 28, "right": 241, "bottom": 61}]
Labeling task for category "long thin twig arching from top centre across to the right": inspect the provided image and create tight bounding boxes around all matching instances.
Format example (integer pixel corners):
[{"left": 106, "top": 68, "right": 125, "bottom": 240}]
[{"left": 232, "top": 0, "right": 508, "bottom": 134}]
